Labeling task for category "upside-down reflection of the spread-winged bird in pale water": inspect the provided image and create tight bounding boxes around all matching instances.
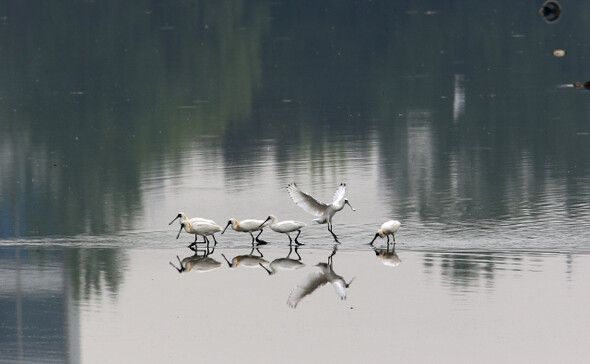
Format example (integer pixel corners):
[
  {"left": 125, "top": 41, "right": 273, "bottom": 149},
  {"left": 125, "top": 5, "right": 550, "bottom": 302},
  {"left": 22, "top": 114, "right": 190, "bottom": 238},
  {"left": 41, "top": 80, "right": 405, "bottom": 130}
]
[{"left": 287, "top": 246, "right": 354, "bottom": 308}]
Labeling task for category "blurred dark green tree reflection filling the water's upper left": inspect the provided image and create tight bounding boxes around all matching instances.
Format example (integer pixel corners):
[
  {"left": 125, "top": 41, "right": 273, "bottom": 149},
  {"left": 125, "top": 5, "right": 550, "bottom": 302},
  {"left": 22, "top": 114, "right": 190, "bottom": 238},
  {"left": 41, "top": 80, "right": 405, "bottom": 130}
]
[{"left": 0, "top": 1, "right": 269, "bottom": 236}]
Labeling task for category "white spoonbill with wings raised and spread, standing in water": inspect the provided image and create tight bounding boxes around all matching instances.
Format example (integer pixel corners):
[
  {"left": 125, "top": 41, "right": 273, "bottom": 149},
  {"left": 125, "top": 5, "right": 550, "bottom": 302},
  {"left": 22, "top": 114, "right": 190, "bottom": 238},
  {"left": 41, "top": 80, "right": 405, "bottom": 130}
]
[{"left": 287, "top": 183, "right": 356, "bottom": 243}]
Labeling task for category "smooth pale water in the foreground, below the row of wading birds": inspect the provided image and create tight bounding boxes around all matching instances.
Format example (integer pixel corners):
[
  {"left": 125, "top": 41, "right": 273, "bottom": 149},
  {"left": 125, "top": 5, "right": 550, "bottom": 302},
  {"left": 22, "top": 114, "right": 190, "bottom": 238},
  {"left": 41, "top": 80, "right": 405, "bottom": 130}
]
[{"left": 0, "top": 246, "right": 590, "bottom": 363}]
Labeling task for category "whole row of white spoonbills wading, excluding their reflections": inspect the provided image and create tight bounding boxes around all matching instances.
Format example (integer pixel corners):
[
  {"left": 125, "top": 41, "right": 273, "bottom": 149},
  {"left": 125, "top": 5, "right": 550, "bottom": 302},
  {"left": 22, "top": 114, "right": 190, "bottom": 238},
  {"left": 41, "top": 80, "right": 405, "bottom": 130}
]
[{"left": 169, "top": 183, "right": 401, "bottom": 248}]
